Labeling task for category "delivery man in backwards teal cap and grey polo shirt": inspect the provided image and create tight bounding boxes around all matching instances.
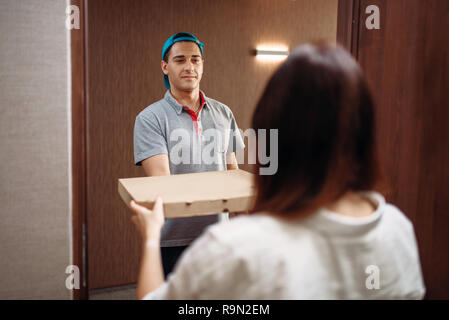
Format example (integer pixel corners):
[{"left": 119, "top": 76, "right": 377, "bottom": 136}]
[{"left": 134, "top": 32, "right": 245, "bottom": 277}]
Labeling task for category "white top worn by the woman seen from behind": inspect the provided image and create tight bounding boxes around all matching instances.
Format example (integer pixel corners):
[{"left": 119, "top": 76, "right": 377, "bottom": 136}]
[{"left": 144, "top": 192, "right": 425, "bottom": 299}]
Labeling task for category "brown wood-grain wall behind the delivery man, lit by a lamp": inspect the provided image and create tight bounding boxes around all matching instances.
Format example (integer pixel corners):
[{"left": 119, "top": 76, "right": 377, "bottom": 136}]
[{"left": 86, "top": 0, "right": 337, "bottom": 289}]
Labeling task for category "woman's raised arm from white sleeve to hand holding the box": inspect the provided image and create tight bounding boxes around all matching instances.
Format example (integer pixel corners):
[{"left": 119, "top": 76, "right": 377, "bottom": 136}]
[{"left": 130, "top": 197, "right": 238, "bottom": 300}]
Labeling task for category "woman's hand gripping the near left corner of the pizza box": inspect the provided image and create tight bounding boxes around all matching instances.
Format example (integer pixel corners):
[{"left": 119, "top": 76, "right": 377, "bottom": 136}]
[{"left": 129, "top": 196, "right": 165, "bottom": 241}]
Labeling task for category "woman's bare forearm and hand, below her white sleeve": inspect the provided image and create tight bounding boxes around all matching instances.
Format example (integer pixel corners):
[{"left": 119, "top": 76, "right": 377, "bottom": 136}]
[{"left": 130, "top": 197, "right": 164, "bottom": 300}]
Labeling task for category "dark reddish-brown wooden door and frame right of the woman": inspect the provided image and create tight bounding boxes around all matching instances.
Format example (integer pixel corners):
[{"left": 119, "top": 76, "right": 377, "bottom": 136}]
[{"left": 358, "top": 0, "right": 449, "bottom": 299}]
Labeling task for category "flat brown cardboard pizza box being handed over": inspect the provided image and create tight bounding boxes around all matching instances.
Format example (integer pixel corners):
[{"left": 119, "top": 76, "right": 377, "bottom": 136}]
[{"left": 118, "top": 169, "right": 255, "bottom": 218}]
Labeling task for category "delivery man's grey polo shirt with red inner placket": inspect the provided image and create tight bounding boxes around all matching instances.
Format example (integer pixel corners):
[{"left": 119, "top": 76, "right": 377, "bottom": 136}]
[{"left": 134, "top": 90, "right": 245, "bottom": 247}]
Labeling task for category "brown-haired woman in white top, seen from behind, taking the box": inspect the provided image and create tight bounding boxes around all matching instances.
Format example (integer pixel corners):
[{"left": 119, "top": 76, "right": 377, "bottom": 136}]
[{"left": 130, "top": 45, "right": 425, "bottom": 299}]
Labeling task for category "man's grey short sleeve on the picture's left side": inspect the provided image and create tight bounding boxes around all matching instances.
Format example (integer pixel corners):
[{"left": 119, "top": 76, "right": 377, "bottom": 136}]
[{"left": 134, "top": 112, "right": 168, "bottom": 166}]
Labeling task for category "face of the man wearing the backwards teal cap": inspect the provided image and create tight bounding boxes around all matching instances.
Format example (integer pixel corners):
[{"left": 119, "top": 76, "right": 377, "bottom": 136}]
[{"left": 161, "top": 41, "right": 203, "bottom": 91}]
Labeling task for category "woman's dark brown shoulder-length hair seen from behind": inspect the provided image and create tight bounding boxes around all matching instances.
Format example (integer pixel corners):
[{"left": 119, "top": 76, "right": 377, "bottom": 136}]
[{"left": 252, "top": 44, "right": 381, "bottom": 216}]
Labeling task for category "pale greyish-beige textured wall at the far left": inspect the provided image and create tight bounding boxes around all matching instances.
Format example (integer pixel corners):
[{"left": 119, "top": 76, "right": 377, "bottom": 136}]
[{"left": 0, "top": 0, "right": 71, "bottom": 299}]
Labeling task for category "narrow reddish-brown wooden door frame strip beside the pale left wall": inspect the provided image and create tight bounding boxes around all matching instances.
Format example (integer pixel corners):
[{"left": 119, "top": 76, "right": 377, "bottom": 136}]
[{"left": 70, "top": 0, "right": 88, "bottom": 300}]
